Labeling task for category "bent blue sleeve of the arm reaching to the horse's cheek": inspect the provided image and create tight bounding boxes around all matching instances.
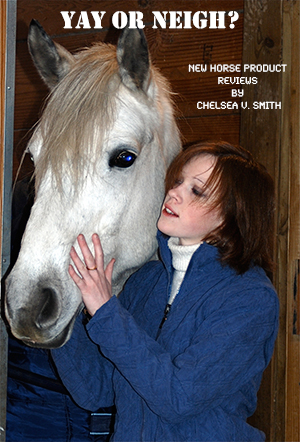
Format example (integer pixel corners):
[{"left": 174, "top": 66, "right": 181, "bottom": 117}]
[{"left": 87, "top": 289, "right": 278, "bottom": 423}]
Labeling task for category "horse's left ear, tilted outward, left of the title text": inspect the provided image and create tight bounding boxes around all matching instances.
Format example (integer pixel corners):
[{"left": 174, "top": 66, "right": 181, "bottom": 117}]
[{"left": 28, "top": 20, "right": 74, "bottom": 89}]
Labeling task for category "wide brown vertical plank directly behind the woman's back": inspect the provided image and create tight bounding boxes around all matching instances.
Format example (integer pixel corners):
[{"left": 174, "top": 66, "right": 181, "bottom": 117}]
[{"left": 241, "top": 0, "right": 288, "bottom": 442}]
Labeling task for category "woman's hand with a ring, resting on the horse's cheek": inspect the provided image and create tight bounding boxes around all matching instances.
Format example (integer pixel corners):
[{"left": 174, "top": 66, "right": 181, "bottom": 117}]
[{"left": 69, "top": 233, "right": 115, "bottom": 316}]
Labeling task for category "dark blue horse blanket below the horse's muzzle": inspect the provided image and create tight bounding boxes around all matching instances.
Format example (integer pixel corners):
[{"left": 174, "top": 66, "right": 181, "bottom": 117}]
[{"left": 6, "top": 337, "right": 99, "bottom": 442}]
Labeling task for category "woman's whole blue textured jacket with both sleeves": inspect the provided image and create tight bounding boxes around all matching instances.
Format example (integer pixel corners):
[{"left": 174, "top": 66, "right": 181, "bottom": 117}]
[{"left": 52, "top": 234, "right": 279, "bottom": 442}]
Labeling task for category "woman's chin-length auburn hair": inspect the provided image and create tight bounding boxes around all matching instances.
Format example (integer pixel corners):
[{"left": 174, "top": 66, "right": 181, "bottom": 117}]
[{"left": 165, "top": 141, "right": 275, "bottom": 275}]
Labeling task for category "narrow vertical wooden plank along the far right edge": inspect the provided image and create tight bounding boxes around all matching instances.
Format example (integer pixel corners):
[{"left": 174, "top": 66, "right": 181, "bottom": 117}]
[{"left": 282, "top": 0, "right": 300, "bottom": 442}]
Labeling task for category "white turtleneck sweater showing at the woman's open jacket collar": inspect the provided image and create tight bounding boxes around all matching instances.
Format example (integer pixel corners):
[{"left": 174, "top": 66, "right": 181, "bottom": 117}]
[{"left": 168, "top": 237, "right": 202, "bottom": 305}]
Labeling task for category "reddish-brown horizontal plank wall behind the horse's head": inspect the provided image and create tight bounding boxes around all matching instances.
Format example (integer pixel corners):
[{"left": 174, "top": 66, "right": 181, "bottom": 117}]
[{"left": 14, "top": 0, "right": 243, "bottom": 178}]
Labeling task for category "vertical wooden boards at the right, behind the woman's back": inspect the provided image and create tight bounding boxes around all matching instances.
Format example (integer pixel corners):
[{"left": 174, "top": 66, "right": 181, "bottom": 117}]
[{"left": 240, "top": 0, "right": 300, "bottom": 442}]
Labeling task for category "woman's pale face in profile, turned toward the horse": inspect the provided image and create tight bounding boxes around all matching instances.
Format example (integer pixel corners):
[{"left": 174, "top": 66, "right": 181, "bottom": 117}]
[{"left": 157, "top": 154, "right": 222, "bottom": 245}]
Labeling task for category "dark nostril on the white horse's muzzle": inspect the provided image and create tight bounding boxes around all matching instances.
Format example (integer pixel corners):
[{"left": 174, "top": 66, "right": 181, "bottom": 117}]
[{"left": 36, "top": 288, "right": 59, "bottom": 328}]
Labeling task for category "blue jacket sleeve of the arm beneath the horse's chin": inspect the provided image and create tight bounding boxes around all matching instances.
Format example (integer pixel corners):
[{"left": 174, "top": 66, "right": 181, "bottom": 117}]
[{"left": 51, "top": 315, "right": 114, "bottom": 411}]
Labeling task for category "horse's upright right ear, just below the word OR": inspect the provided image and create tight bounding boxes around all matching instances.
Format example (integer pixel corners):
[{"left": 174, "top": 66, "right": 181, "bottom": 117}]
[{"left": 117, "top": 27, "right": 150, "bottom": 92}]
